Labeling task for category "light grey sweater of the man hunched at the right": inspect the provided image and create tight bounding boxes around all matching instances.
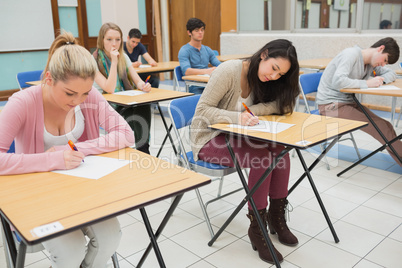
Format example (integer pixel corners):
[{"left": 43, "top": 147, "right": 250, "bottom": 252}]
[{"left": 316, "top": 46, "right": 396, "bottom": 104}]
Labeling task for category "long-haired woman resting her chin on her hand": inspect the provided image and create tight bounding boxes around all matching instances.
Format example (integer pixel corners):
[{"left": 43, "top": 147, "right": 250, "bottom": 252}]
[{"left": 93, "top": 22, "right": 151, "bottom": 154}]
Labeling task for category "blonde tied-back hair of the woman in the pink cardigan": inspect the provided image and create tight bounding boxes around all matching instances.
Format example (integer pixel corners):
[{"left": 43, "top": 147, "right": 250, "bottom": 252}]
[{"left": 43, "top": 32, "right": 97, "bottom": 82}]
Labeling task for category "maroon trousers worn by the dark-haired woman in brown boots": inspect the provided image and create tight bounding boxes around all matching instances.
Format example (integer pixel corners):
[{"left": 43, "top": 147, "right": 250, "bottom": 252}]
[{"left": 198, "top": 134, "right": 290, "bottom": 210}]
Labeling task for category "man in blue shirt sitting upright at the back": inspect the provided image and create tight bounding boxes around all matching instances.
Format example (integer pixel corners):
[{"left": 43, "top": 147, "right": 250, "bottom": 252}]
[{"left": 179, "top": 18, "right": 221, "bottom": 94}]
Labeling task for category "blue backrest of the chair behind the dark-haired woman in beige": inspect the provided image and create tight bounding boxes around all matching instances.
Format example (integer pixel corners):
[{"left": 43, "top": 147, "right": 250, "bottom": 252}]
[{"left": 168, "top": 95, "right": 201, "bottom": 129}]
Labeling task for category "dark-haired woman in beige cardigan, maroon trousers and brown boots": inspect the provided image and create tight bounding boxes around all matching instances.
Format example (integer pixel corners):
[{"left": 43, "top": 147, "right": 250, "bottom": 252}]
[{"left": 190, "top": 39, "right": 299, "bottom": 263}]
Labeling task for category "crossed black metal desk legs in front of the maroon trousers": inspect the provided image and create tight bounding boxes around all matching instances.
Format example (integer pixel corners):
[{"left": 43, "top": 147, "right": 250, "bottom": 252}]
[{"left": 208, "top": 135, "right": 292, "bottom": 267}]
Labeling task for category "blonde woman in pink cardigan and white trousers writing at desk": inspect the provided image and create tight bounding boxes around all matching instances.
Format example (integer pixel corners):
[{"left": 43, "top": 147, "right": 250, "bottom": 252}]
[{"left": 0, "top": 33, "right": 134, "bottom": 268}]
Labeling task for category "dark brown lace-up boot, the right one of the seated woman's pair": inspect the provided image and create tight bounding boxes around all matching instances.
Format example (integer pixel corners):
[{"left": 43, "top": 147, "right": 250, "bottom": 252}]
[{"left": 267, "top": 198, "right": 299, "bottom": 246}]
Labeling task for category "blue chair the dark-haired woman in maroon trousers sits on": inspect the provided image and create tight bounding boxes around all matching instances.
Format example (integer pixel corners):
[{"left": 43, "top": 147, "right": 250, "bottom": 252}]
[{"left": 168, "top": 95, "right": 243, "bottom": 237}]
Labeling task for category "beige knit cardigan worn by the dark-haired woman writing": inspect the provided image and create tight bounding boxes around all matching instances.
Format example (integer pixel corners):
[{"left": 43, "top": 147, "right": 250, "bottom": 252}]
[{"left": 190, "top": 60, "right": 279, "bottom": 160}]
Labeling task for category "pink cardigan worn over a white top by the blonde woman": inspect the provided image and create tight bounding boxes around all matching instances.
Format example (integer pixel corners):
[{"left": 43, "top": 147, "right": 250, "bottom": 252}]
[{"left": 0, "top": 85, "right": 134, "bottom": 175}]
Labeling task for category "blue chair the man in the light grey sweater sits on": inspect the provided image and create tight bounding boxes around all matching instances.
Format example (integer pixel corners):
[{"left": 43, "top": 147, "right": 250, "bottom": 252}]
[{"left": 299, "top": 72, "right": 361, "bottom": 170}]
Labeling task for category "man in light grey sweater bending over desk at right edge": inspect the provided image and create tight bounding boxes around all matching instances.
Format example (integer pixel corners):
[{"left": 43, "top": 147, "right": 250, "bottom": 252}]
[{"left": 317, "top": 37, "right": 402, "bottom": 165}]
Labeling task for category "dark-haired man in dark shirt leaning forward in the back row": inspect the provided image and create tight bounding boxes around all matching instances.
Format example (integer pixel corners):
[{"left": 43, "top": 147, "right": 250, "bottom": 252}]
[{"left": 123, "top": 28, "right": 159, "bottom": 87}]
